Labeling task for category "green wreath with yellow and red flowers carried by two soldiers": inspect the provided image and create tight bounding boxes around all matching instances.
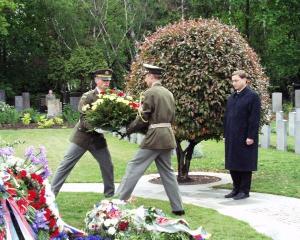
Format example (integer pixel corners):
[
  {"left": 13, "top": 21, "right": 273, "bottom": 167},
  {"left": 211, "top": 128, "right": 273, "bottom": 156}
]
[{"left": 82, "top": 89, "right": 140, "bottom": 132}]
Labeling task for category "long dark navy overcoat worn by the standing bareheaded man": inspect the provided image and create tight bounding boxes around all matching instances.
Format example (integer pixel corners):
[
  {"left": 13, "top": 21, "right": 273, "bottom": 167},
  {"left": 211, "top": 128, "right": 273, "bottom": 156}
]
[{"left": 224, "top": 86, "right": 261, "bottom": 171}]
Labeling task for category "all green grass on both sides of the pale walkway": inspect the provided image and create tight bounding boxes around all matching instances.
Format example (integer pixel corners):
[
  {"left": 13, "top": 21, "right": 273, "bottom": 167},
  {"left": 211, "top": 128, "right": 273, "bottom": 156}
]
[{"left": 0, "top": 129, "right": 300, "bottom": 239}]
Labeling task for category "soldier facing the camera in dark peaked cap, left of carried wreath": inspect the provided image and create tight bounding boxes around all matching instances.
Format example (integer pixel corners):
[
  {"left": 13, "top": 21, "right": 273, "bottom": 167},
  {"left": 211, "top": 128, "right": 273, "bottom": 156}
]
[{"left": 51, "top": 69, "right": 115, "bottom": 197}]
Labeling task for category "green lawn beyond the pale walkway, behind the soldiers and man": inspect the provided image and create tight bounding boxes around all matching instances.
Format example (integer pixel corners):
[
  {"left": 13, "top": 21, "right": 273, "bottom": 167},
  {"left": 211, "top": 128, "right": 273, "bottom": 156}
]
[{"left": 0, "top": 129, "right": 300, "bottom": 198}]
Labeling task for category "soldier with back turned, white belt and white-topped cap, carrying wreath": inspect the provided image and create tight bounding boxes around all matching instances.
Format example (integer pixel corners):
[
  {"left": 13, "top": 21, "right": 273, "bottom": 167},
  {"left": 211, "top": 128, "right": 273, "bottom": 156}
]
[{"left": 117, "top": 64, "right": 185, "bottom": 215}]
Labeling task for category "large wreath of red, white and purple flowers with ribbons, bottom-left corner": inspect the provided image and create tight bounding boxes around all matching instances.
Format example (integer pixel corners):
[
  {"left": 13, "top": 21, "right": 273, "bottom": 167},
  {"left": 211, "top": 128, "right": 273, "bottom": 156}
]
[{"left": 0, "top": 146, "right": 84, "bottom": 240}]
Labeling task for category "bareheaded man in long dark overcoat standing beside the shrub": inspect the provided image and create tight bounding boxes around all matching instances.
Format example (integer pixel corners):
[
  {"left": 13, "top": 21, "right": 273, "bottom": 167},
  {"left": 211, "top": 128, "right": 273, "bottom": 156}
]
[{"left": 224, "top": 70, "right": 261, "bottom": 200}]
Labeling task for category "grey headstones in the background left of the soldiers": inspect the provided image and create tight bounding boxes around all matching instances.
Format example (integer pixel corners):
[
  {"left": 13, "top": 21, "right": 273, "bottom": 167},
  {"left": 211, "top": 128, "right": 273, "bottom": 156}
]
[{"left": 0, "top": 89, "right": 80, "bottom": 118}]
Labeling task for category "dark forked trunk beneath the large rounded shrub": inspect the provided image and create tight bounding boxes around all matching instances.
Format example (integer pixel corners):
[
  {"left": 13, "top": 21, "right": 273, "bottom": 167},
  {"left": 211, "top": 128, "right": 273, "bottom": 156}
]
[{"left": 176, "top": 139, "right": 200, "bottom": 182}]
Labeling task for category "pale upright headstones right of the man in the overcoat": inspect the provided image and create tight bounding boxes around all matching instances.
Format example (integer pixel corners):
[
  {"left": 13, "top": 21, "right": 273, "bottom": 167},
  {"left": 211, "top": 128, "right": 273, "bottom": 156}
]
[{"left": 260, "top": 90, "right": 300, "bottom": 154}]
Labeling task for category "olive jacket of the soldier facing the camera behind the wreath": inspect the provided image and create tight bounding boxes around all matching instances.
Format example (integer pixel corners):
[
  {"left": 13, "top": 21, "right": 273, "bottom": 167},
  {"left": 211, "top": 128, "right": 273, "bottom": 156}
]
[{"left": 70, "top": 88, "right": 107, "bottom": 149}]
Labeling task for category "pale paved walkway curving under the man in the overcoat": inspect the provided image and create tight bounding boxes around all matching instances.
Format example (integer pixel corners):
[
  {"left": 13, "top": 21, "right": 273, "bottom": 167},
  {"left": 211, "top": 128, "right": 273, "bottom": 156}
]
[{"left": 62, "top": 172, "right": 300, "bottom": 240}]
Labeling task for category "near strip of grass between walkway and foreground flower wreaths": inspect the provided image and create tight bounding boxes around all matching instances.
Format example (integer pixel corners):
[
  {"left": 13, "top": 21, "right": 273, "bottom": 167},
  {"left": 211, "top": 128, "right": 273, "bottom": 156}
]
[{"left": 57, "top": 193, "right": 270, "bottom": 240}]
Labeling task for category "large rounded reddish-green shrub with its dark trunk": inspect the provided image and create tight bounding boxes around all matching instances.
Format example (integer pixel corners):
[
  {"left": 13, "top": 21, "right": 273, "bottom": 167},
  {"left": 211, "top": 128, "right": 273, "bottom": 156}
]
[{"left": 127, "top": 19, "right": 269, "bottom": 179}]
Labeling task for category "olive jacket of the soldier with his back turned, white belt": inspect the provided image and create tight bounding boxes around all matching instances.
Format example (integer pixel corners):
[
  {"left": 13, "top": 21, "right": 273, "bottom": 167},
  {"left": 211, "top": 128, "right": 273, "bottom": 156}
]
[{"left": 127, "top": 82, "right": 176, "bottom": 149}]
